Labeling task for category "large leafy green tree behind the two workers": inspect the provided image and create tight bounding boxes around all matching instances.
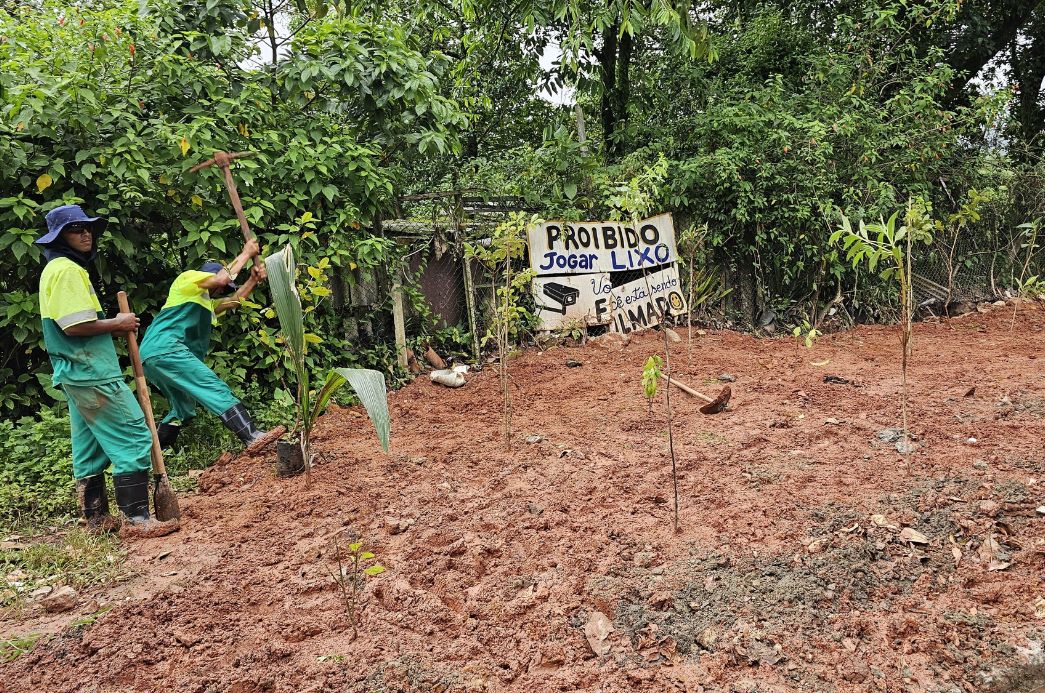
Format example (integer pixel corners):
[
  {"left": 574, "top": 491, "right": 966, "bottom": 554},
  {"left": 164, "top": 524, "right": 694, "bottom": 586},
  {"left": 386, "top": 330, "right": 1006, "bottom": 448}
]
[{"left": 0, "top": 0, "right": 466, "bottom": 410}]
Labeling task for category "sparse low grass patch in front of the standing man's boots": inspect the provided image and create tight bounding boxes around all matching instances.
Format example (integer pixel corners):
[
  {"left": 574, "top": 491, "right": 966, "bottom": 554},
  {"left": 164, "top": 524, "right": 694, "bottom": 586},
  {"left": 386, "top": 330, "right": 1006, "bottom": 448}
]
[{"left": 0, "top": 527, "right": 130, "bottom": 610}]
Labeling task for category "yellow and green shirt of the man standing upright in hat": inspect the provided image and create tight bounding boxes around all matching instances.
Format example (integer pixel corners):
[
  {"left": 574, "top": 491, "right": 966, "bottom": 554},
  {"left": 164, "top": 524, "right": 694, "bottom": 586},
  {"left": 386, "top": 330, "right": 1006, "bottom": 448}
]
[{"left": 40, "top": 257, "right": 123, "bottom": 387}]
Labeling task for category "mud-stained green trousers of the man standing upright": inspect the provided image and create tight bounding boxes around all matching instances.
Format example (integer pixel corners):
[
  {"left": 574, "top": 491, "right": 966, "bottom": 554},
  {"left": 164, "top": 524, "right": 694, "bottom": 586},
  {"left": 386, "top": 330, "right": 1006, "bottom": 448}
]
[{"left": 62, "top": 380, "right": 153, "bottom": 479}]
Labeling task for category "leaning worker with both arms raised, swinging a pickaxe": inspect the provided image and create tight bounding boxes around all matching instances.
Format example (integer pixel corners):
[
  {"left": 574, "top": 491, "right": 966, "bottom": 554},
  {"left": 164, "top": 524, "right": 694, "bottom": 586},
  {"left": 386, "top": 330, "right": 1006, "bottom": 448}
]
[{"left": 140, "top": 239, "right": 285, "bottom": 454}]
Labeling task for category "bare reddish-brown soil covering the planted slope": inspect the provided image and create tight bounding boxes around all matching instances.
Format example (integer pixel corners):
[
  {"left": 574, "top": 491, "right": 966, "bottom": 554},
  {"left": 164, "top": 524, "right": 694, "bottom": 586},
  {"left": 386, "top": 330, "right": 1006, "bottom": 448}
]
[{"left": 0, "top": 304, "right": 1045, "bottom": 693}]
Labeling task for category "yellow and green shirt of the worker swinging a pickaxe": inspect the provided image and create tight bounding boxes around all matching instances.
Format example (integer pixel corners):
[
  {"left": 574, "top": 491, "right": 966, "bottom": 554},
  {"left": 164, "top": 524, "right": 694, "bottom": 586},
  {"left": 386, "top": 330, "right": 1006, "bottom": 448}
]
[{"left": 140, "top": 270, "right": 220, "bottom": 361}]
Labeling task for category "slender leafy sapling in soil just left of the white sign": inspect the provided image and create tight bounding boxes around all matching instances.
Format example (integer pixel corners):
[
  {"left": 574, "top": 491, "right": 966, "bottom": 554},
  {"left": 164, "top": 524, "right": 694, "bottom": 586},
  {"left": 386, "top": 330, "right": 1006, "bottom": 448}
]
[{"left": 465, "top": 212, "right": 543, "bottom": 447}]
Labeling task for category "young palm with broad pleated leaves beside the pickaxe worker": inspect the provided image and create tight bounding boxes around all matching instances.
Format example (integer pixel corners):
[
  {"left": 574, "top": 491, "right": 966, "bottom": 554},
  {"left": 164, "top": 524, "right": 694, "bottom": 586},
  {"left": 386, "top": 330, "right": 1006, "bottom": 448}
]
[{"left": 264, "top": 245, "right": 392, "bottom": 480}]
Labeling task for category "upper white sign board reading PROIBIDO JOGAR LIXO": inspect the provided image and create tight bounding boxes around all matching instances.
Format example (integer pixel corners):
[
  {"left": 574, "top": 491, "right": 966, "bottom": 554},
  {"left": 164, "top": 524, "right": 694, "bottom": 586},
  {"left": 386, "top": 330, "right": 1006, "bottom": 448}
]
[{"left": 528, "top": 214, "right": 676, "bottom": 276}]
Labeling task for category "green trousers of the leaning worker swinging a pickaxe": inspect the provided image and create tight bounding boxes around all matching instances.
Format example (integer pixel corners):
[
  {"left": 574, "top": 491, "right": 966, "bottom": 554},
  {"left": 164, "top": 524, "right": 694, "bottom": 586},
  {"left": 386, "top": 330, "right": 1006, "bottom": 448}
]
[{"left": 143, "top": 349, "right": 239, "bottom": 423}]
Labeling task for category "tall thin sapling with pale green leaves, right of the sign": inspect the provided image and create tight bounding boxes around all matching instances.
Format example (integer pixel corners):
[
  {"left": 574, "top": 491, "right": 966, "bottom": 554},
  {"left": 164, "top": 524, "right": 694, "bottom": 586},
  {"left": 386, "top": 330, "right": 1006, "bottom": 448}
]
[{"left": 831, "top": 199, "right": 934, "bottom": 453}]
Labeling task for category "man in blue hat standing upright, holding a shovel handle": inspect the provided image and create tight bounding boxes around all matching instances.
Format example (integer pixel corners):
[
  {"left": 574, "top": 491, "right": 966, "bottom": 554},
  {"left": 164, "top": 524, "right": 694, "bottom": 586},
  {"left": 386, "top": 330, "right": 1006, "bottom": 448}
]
[{"left": 36, "top": 205, "right": 178, "bottom": 536}]
